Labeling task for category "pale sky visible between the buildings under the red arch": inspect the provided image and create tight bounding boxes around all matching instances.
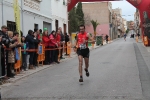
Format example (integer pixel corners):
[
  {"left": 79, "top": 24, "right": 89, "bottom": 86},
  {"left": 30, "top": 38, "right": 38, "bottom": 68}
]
[{"left": 111, "top": 0, "right": 136, "bottom": 21}]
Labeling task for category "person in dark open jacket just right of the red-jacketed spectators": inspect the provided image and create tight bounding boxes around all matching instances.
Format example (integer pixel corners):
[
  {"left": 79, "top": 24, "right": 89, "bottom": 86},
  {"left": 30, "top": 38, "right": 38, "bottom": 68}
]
[{"left": 58, "top": 27, "right": 65, "bottom": 59}]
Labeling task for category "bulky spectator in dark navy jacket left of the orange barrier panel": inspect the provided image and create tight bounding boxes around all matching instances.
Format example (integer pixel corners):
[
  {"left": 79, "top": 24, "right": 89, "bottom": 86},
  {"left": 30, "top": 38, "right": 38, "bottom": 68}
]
[{"left": 26, "top": 30, "right": 36, "bottom": 69}]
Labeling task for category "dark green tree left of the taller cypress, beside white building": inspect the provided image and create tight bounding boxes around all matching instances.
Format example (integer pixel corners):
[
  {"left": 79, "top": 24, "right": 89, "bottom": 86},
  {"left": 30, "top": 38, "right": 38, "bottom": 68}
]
[{"left": 68, "top": 7, "right": 78, "bottom": 33}]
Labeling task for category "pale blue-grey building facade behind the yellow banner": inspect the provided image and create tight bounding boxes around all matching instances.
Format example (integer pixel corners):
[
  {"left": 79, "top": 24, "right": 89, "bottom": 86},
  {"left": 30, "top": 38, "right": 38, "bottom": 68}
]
[{"left": 0, "top": 0, "right": 52, "bottom": 35}]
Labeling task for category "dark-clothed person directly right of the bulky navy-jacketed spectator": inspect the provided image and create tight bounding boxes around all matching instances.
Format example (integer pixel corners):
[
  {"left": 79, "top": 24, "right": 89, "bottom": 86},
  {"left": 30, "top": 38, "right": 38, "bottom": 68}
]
[{"left": 33, "top": 31, "right": 40, "bottom": 67}]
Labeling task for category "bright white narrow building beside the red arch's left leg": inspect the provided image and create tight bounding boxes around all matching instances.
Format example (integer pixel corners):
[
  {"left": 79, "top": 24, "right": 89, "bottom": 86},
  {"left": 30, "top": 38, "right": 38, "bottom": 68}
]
[{"left": 51, "top": 0, "right": 68, "bottom": 33}]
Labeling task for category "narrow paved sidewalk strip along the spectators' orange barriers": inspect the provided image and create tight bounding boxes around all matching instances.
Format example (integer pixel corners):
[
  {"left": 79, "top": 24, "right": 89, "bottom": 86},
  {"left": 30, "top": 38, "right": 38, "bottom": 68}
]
[{"left": 1, "top": 46, "right": 100, "bottom": 87}]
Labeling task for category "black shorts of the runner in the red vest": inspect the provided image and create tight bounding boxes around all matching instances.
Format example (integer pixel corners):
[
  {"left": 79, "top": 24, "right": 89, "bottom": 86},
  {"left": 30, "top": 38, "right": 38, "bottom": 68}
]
[{"left": 77, "top": 48, "right": 90, "bottom": 58}]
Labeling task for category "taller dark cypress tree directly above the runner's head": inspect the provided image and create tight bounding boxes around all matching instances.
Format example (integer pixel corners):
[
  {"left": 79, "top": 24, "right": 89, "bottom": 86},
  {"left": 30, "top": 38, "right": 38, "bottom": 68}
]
[{"left": 76, "top": 2, "right": 85, "bottom": 26}]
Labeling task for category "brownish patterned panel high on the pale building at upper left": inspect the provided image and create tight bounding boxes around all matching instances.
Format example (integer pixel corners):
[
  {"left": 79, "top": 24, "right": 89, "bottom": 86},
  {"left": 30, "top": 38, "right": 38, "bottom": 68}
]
[{"left": 24, "top": 0, "right": 40, "bottom": 11}]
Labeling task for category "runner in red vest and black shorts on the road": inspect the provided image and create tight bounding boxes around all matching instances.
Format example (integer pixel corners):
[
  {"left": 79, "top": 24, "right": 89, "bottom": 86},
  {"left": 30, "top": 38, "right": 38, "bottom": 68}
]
[{"left": 76, "top": 25, "right": 94, "bottom": 82}]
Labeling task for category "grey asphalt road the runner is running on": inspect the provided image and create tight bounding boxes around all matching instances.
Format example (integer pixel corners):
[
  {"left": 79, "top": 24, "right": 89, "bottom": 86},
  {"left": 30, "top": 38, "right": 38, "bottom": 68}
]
[{"left": 2, "top": 37, "right": 150, "bottom": 100}]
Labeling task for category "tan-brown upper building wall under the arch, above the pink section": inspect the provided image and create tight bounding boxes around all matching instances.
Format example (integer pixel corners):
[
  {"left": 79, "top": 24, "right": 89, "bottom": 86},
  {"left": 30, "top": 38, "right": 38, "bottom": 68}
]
[{"left": 82, "top": 2, "right": 109, "bottom": 24}]
